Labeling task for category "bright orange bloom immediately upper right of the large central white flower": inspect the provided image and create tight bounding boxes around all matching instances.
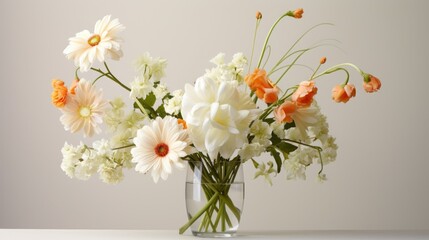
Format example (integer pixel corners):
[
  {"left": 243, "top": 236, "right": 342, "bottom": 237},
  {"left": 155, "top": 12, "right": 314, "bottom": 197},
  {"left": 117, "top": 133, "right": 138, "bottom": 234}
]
[{"left": 244, "top": 68, "right": 279, "bottom": 103}]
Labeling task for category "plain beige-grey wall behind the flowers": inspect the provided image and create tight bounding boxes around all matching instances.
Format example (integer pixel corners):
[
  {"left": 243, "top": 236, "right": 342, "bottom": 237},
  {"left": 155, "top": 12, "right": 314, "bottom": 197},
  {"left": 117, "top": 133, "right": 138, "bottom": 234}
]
[{"left": 0, "top": 0, "right": 429, "bottom": 230}]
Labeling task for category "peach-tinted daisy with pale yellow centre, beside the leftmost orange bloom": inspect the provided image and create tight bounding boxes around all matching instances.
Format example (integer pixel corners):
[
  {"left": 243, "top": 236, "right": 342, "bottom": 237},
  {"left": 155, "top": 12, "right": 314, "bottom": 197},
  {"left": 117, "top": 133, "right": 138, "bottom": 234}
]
[{"left": 60, "top": 78, "right": 107, "bottom": 137}]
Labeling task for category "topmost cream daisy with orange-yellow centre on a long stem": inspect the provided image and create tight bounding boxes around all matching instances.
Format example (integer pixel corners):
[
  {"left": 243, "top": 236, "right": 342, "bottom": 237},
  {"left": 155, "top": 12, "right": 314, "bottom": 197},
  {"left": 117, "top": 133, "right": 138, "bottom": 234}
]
[{"left": 63, "top": 15, "right": 125, "bottom": 72}]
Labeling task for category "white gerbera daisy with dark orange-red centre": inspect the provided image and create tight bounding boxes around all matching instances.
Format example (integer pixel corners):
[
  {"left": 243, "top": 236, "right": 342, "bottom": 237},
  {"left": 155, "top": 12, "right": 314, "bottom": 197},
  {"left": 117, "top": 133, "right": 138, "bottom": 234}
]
[{"left": 131, "top": 116, "right": 190, "bottom": 183}]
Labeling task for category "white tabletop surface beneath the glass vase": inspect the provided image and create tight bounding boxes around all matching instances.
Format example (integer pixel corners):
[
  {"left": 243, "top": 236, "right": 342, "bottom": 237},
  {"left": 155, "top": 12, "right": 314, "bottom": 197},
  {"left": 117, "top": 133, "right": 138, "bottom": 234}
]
[{"left": 0, "top": 229, "right": 429, "bottom": 240}]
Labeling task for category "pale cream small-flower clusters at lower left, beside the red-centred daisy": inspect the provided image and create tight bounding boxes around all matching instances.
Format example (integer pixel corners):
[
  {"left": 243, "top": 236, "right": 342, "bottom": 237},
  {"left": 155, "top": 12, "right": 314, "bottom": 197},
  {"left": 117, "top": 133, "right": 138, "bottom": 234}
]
[{"left": 61, "top": 98, "right": 145, "bottom": 184}]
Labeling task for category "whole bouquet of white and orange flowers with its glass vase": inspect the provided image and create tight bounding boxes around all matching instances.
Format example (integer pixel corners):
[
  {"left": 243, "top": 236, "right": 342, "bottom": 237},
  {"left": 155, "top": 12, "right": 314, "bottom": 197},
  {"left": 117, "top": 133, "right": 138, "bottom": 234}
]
[{"left": 51, "top": 9, "right": 381, "bottom": 236}]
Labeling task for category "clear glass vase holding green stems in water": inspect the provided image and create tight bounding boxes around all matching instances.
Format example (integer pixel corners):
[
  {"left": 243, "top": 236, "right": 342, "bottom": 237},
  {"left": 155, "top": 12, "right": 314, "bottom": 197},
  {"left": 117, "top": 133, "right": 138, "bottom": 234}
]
[{"left": 185, "top": 160, "right": 244, "bottom": 237}]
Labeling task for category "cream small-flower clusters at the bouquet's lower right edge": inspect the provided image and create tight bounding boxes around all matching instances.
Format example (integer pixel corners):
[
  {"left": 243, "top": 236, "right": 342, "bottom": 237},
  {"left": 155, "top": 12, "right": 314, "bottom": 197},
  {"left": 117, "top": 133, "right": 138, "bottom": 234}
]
[{"left": 283, "top": 101, "right": 338, "bottom": 181}]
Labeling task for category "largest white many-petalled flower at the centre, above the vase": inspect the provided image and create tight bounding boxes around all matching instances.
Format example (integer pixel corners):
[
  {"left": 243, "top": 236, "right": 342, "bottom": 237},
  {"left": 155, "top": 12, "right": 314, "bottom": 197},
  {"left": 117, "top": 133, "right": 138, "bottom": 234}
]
[{"left": 182, "top": 77, "right": 259, "bottom": 159}]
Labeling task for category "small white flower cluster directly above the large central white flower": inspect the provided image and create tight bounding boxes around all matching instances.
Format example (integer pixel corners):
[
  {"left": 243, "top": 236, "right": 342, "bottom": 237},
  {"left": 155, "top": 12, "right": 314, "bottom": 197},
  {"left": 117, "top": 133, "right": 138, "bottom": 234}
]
[{"left": 204, "top": 53, "right": 247, "bottom": 83}]
